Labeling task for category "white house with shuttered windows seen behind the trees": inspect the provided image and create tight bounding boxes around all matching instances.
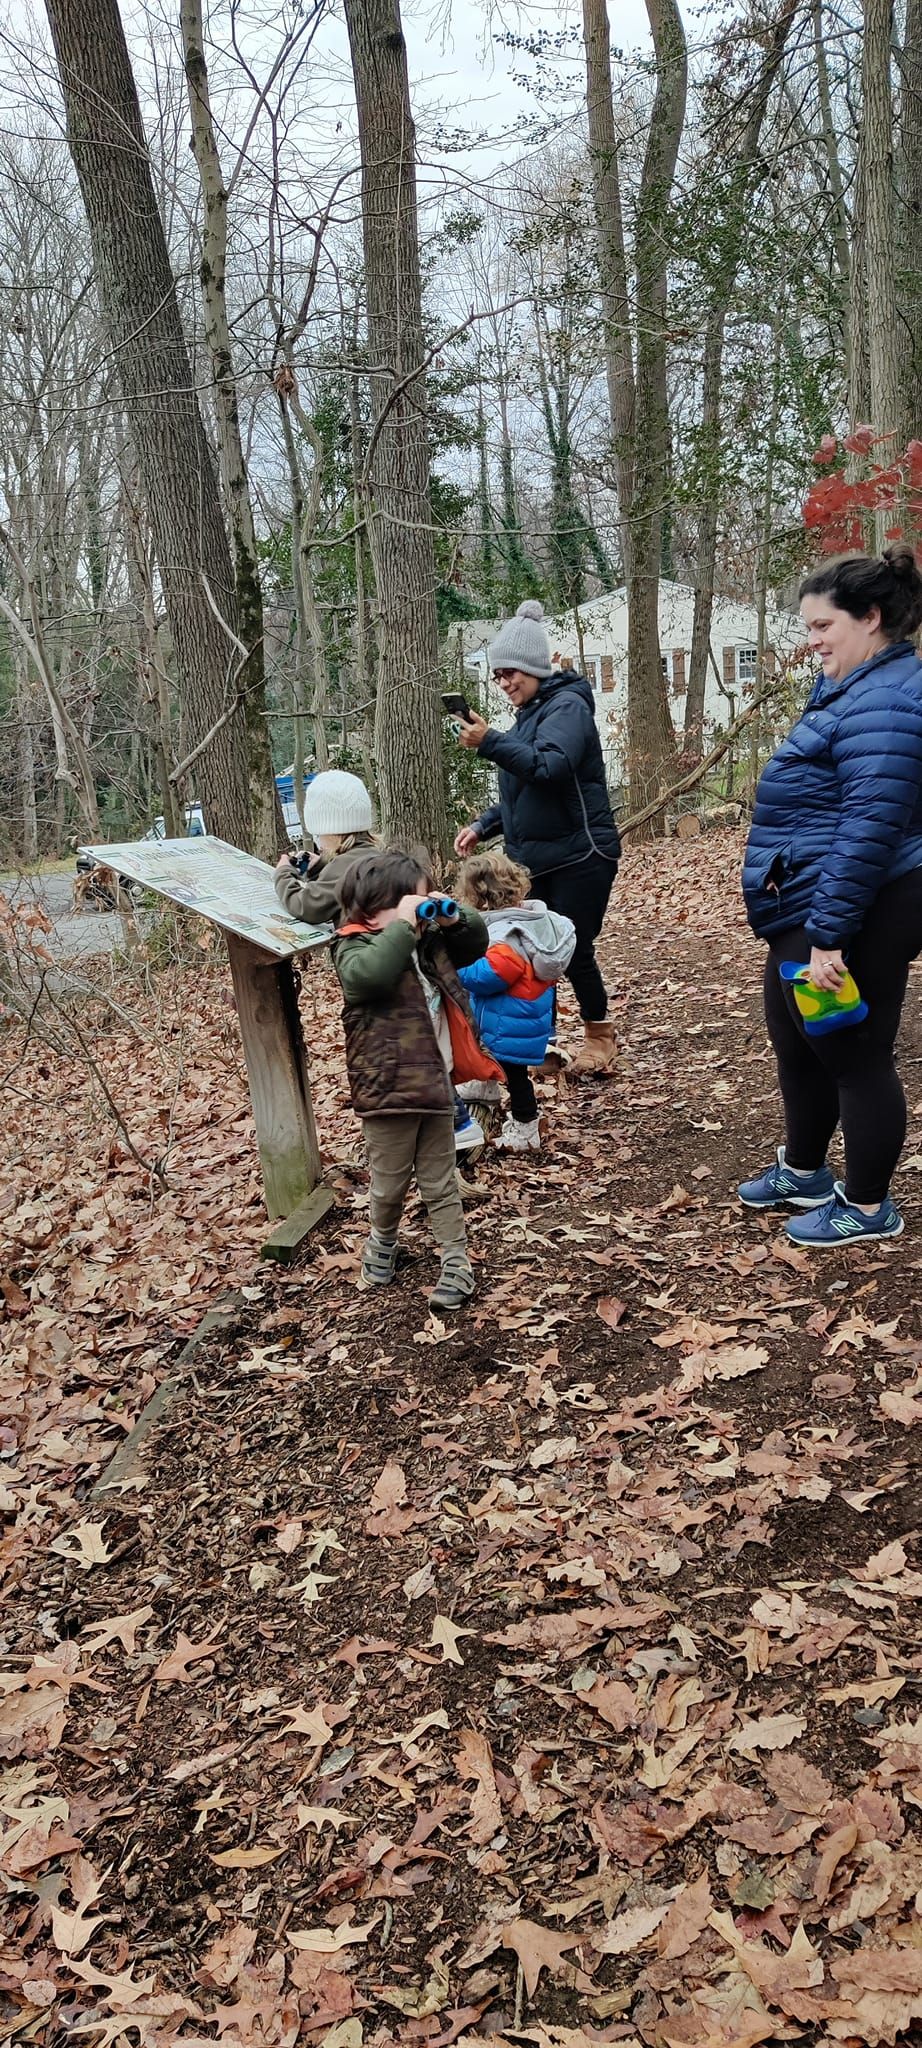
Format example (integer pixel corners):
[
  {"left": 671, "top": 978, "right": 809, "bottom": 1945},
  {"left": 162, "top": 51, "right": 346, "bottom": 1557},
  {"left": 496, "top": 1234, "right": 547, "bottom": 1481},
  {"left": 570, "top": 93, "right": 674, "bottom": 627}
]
[{"left": 449, "top": 582, "right": 803, "bottom": 774}]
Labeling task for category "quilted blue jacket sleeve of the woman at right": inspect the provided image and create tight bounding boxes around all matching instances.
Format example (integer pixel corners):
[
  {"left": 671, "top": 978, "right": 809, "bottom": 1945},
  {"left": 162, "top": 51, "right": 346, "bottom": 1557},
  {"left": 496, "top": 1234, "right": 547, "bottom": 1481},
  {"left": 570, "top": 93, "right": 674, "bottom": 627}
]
[{"left": 807, "top": 690, "right": 922, "bottom": 950}]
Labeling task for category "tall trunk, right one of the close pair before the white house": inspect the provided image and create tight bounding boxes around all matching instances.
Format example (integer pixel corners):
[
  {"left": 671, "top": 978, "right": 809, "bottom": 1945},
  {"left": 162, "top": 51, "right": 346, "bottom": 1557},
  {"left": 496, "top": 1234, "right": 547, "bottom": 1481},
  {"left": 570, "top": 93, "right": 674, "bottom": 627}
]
[{"left": 627, "top": 0, "right": 688, "bottom": 809}]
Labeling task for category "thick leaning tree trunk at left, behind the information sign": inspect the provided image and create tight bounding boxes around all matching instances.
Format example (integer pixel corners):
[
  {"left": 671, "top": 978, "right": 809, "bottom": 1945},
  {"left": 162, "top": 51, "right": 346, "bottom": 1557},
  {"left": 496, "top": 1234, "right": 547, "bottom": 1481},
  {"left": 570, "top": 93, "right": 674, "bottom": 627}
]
[{"left": 47, "top": 0, "right": 252, "bottom": 848}]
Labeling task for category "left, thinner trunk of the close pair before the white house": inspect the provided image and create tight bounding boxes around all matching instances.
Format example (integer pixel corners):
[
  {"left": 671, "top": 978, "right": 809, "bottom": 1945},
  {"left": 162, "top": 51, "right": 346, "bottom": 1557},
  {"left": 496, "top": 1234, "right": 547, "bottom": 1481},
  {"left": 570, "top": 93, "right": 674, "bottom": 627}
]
[{"left": 582, "top": 0, "right": 635, "bottom": 582}]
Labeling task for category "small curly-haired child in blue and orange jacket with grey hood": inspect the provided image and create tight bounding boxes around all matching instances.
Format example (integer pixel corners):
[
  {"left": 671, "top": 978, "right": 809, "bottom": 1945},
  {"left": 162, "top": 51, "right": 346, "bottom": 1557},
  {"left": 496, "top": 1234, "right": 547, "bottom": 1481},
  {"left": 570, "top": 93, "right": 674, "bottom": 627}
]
[{"left": 455, "top": 854, "right": 576, "bottom": 1151}]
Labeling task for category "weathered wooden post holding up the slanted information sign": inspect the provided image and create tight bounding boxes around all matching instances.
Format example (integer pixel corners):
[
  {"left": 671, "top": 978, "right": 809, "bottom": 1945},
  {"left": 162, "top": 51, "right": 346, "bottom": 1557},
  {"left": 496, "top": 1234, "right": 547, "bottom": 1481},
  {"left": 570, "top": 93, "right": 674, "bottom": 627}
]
[{"left": 225, "top": 932, "right": 332, "bottom": 1260}]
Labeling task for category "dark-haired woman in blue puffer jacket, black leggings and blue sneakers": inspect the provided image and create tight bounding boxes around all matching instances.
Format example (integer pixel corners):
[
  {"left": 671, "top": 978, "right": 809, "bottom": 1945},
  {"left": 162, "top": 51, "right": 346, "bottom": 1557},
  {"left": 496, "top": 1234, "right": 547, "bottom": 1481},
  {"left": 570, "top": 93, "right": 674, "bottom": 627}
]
[{"left": 740, "top": 547, "right": 922, "bottom": 1245}]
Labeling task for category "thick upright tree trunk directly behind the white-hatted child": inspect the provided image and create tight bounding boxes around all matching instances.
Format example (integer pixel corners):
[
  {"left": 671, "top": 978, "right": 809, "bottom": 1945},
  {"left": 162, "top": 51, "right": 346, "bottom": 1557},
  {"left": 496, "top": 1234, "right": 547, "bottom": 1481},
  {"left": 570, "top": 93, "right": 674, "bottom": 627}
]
[{"left": 344, "top": 0, "right": 447, "bottom": 854}]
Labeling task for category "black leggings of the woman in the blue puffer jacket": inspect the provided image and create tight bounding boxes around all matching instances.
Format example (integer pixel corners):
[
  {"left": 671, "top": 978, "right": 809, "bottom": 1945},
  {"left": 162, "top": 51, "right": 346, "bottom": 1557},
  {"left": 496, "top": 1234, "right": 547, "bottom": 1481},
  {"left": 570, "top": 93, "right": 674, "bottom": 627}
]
[{"left": 764, "top": 868, "right": 922, "bottom": 1202}]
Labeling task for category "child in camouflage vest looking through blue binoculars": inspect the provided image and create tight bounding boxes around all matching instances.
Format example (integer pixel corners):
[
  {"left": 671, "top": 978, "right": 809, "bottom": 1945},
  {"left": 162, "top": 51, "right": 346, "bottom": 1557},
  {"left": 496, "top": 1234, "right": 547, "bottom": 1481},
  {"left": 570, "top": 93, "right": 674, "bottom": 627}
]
[{"left": 332, "top": 852, "right": 502, "bottom": 1309}]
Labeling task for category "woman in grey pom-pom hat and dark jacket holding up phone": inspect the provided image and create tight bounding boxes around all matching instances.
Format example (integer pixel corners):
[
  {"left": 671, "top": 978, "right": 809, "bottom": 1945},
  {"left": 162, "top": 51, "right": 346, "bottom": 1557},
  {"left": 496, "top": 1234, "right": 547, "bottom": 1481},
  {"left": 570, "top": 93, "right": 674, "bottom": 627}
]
[{"left": 455, "top": 598, "right": 621, "bottom": 1073}]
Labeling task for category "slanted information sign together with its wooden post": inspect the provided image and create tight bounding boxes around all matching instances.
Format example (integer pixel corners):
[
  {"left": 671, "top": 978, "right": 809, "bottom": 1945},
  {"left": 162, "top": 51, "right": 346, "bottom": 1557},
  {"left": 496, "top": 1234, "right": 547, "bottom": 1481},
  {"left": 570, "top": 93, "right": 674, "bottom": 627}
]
[{"left": 82, "top": 838, "right": 332, "bottom": 1262}]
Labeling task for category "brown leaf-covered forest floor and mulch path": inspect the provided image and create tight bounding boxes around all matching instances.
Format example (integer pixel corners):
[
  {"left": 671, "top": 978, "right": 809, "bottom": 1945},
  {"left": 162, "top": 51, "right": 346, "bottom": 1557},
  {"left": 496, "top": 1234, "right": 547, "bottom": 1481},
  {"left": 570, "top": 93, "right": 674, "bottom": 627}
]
[{"left": 0, "top": 836, "right": 922, "bottom": 2048}]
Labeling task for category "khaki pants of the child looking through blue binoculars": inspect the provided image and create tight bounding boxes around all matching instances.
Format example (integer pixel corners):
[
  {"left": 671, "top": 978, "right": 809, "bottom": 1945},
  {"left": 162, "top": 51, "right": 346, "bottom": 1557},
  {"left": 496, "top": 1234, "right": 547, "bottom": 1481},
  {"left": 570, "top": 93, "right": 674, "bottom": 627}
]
[{"left": 363, "top": 1110, "right": 467, "bottom": 1257}]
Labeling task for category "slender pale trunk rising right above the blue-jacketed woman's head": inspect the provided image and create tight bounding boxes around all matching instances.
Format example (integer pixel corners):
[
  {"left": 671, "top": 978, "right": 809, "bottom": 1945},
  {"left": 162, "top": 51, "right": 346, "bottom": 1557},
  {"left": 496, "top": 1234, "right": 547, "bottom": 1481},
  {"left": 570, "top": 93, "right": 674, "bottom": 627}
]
[{"left": 861, "top": 0, "right": 902, "bottom": 547}]
